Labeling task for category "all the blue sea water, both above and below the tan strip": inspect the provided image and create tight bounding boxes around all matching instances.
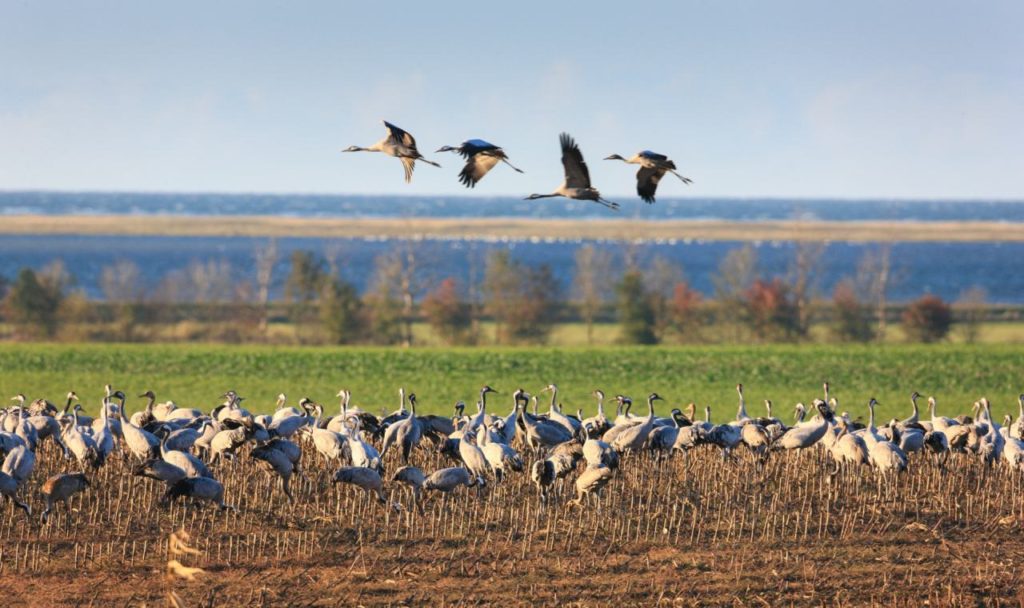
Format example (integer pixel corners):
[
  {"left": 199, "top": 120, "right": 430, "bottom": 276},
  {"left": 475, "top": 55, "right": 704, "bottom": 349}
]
[{"left": 0, "top": 192, "right": 1024, "bottom": 304}]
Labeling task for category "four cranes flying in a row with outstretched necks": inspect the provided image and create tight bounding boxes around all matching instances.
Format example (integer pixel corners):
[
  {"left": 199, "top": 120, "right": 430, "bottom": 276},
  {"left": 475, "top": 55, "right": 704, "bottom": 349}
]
[{"left": 342, "top": 121, "right": 692, "bottom": 210}]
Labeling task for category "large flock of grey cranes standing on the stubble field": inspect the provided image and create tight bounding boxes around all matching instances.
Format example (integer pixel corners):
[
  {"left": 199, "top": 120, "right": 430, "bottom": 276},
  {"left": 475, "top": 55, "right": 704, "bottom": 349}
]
[{"left": 0, "top": 383, "right": 1024, "bottom": 522}]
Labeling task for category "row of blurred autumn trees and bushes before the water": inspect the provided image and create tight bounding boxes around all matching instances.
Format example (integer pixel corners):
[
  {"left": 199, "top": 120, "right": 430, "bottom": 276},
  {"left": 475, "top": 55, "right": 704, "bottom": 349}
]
[{"left": 0, "top": 241, "right": 992, "bottom": 346}]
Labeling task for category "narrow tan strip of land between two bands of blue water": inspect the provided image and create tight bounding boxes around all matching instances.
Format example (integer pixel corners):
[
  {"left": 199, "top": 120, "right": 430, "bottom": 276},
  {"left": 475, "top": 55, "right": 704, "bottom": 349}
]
[{"left": 0, "top": 215, "right": 1024, "bottom": 243}]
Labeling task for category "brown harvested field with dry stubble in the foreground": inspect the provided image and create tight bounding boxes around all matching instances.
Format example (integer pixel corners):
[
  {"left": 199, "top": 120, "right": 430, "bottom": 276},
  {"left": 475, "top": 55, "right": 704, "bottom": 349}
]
[{"left": 0, "top": 436, "right": 1024, "bottom": 606}]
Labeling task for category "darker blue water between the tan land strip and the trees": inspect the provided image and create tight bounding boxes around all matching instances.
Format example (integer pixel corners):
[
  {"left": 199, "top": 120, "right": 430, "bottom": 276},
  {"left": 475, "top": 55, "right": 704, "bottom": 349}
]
[{"left": 0, "top": 235, "right": 1024, "bottom": 304}]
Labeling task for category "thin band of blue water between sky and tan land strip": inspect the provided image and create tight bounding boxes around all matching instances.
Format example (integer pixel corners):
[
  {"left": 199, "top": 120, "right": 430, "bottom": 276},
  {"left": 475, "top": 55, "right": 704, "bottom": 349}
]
[{"left": 6, "top": 191, "right": 1024, "bottom": 222}]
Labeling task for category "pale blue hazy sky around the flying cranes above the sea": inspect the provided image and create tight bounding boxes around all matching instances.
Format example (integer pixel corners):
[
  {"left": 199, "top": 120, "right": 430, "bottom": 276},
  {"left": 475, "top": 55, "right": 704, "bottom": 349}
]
[{"left": 0, "top": 0, "right": 1024, "bottom": 200}]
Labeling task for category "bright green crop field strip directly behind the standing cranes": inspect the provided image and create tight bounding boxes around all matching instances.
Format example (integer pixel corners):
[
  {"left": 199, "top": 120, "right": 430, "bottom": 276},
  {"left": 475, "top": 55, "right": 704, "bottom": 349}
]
[{"left": 0, "top": 344, "right": 1024, "bottom": 421}]
